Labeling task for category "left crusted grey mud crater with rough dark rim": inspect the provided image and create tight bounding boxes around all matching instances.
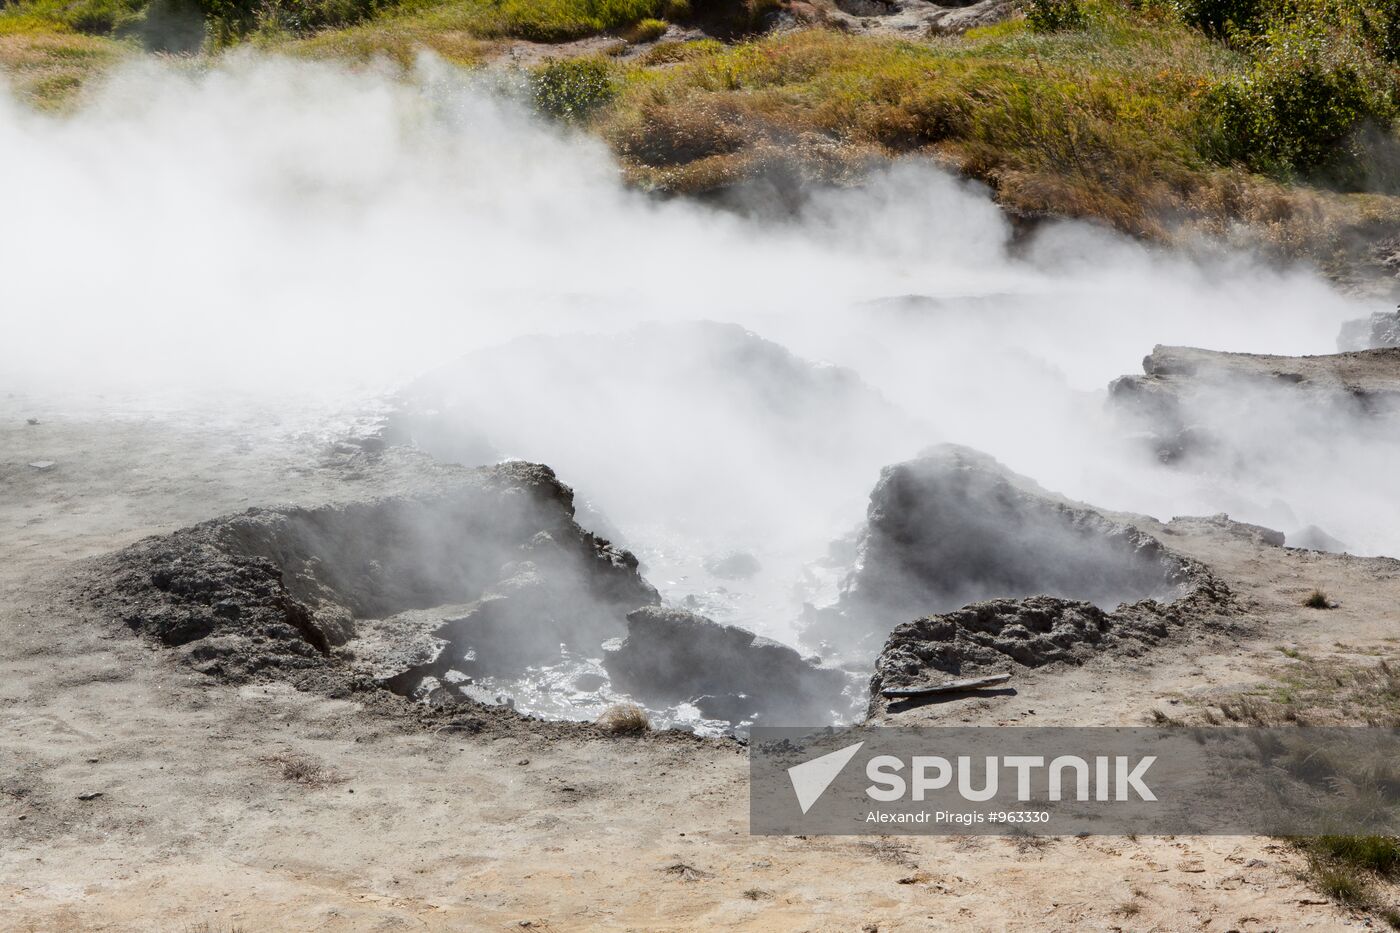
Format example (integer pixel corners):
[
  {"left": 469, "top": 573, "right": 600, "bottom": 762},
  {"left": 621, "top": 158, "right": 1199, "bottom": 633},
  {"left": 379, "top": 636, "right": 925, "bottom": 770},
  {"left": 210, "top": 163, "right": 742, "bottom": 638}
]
[{"left": 88, "top": 462, "right": 658, "bottom": 692}]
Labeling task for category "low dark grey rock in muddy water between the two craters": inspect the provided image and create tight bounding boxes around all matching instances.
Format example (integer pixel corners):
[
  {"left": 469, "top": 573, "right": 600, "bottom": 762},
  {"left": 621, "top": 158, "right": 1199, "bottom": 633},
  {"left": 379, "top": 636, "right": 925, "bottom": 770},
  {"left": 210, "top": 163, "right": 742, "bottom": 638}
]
[{"left": 603, "top": 607, "right": 850, "bottom": 724}]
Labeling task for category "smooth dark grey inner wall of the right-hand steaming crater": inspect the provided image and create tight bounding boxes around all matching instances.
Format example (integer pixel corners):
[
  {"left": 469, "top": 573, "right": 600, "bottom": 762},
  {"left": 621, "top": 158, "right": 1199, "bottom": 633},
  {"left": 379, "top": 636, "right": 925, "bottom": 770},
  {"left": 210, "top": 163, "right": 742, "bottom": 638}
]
[{"left": 809, "top": 445, "right": 1205, "bottom": 653}]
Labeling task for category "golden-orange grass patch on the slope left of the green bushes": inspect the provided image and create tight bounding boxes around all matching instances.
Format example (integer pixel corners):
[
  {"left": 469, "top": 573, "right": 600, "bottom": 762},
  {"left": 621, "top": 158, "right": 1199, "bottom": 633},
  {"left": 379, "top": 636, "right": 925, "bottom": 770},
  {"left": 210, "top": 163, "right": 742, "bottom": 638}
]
[{"left": 601, "top": 7, "right": 1242, "bottom": 233}]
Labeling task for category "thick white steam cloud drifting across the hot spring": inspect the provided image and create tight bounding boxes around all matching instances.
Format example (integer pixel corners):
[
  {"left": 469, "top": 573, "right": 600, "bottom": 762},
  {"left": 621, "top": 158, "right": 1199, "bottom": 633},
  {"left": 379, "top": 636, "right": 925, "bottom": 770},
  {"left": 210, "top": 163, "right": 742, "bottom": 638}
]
[{"left": 0, "top": 55, "right": 1400, "bottom": 652}]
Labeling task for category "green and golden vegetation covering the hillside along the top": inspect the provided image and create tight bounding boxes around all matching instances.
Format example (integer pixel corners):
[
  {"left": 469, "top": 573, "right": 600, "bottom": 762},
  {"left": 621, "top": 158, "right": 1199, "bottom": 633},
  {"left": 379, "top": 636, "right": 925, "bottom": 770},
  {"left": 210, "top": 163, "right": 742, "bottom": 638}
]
[{"left": 0, "top": 0, "right": 1400, "bottom": 262}]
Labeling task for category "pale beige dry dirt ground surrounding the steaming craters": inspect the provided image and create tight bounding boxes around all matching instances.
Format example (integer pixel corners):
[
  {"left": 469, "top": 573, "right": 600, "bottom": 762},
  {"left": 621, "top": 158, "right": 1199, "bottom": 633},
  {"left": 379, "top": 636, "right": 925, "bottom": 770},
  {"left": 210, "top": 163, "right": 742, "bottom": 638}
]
[{"left": 0, "top": 396, "right": 1400, "bottom": 932}]
